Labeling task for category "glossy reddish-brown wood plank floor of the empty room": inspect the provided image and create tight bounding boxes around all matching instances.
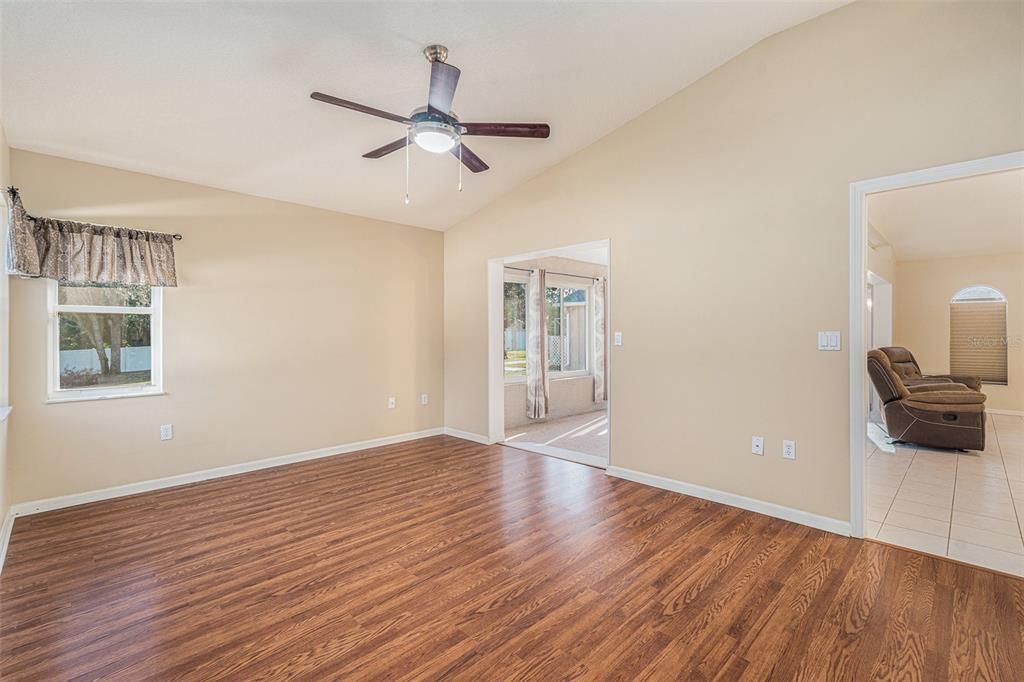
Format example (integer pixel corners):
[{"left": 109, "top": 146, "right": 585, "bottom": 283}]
[{"left": 0, "top": 436, "right": 1024, "bottom": 680}]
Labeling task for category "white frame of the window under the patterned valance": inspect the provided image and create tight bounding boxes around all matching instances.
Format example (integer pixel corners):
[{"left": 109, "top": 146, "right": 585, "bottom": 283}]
[{"left": 46, "top": 280, "right": 164, "bottom": 402}]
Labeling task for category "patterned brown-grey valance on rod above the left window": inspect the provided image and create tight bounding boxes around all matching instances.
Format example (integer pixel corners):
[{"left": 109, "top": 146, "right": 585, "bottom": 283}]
[{"left": 7, "top": 187, "right": 178, "bottom": 287}]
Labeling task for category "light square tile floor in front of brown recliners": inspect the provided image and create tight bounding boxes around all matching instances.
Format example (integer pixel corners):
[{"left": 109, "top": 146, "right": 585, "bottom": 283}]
[{"left": 865, "top": 415, "right": 1024, "bottom": 577}]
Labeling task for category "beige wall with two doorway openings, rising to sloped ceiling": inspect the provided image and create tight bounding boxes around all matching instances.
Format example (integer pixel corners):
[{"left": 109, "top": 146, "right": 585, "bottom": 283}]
[{"left": 444, "top": 3, "right": 1024, "bottom": 519}]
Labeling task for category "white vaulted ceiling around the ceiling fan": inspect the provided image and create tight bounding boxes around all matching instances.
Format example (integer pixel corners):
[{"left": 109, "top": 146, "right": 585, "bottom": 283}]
[{"left": 0, "top": 0, "right": 844, "bottom": 229}]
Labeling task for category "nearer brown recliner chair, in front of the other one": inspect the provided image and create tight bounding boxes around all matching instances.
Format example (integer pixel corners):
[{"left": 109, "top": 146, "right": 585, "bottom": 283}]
[{"left": 867, "top": 350, "right": 986, "bottom": 450}]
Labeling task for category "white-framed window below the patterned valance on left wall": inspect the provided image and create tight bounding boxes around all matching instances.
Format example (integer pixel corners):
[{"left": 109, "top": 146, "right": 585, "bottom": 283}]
[{"left": 49, "top": 282, "right": 163, "bottom": 400}]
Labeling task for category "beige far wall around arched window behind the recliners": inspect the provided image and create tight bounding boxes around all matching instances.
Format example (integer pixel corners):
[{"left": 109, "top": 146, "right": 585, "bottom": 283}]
[{"left": 893, "top": 253, "right": 1024, "bottom": 412}]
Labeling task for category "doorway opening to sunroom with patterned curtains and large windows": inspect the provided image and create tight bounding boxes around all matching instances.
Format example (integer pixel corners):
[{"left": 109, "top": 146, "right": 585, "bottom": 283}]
[{"left": 488, "top": 241, "right": 610, "bottom": 468}]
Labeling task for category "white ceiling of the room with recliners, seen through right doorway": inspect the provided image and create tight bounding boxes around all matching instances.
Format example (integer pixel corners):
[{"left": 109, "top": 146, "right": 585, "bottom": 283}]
[{"left": 867, "top": 170, "right": 1024, "bottom": 260}]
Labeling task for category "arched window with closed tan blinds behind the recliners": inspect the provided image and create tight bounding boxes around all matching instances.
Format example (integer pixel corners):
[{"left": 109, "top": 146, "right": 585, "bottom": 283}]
[{"left": 949, "top": 286, "right": 1009, "bottom": 384}]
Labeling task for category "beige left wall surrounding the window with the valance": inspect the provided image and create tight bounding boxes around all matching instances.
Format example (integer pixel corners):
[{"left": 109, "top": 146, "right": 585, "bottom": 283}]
[{"left": 9, "top": 150, "right": 443, "bottom": 503}]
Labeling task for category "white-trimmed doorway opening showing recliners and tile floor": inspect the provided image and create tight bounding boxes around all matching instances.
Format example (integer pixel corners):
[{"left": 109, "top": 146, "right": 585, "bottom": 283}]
[{"left": 850, "top": 153, "right": 1024, "bottom": 576}]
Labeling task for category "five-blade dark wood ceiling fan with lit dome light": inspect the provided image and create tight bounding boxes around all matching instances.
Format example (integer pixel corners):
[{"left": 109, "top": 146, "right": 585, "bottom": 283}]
[{"left": 309, "top": 45, "right": 551, "bottom": 173}]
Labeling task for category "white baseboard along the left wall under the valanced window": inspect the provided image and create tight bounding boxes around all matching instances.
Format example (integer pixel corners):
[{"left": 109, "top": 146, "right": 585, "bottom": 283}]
[{"left": 8, "top": 427, "right": 444, "bottom": 516}]
